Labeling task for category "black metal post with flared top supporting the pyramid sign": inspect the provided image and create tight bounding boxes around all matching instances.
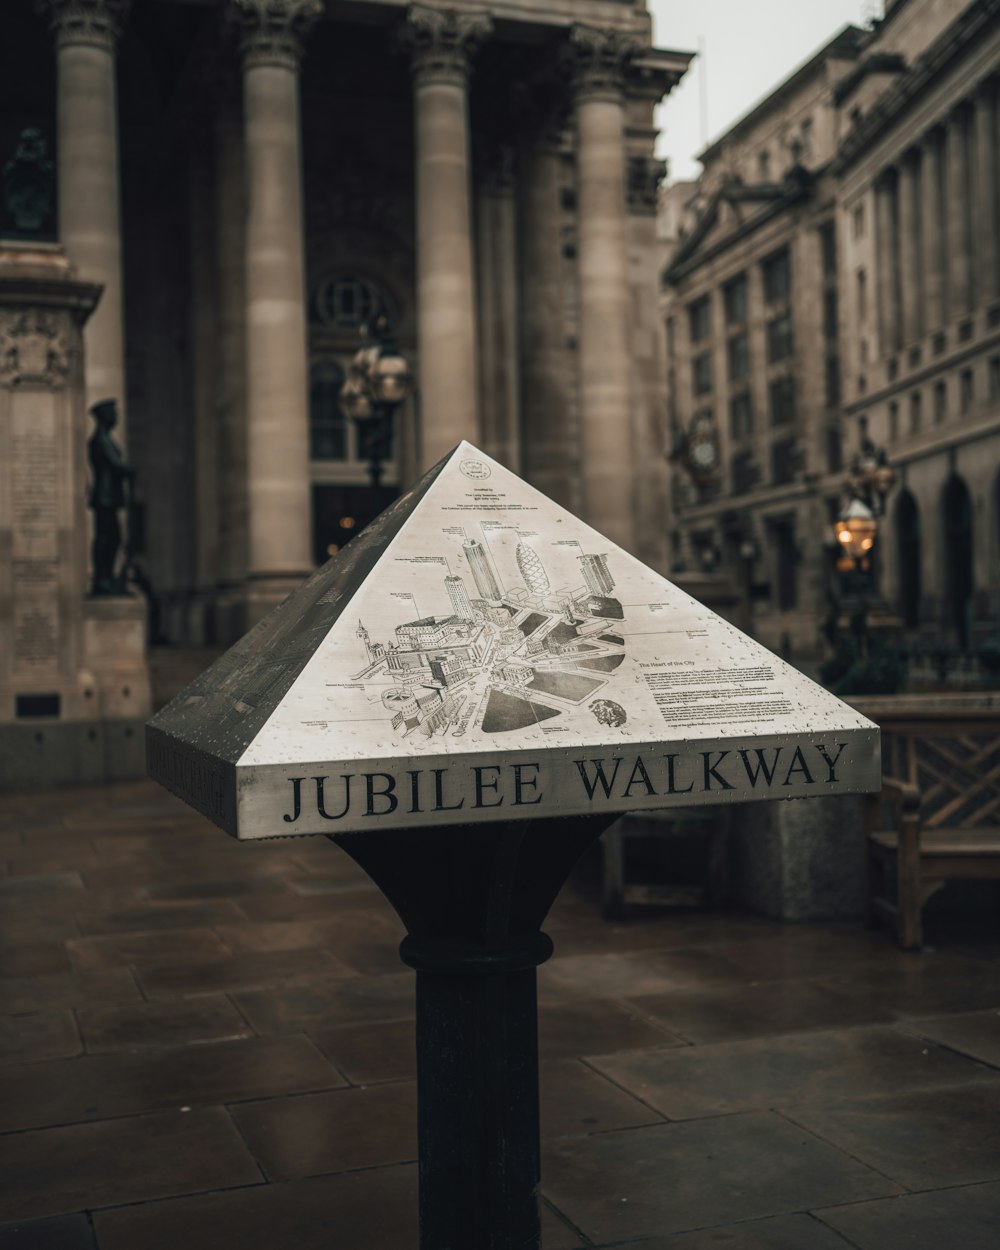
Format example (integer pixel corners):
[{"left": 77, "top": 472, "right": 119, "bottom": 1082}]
[{"left": 333, "top": 815, "right": 615, "bottom": 1250}]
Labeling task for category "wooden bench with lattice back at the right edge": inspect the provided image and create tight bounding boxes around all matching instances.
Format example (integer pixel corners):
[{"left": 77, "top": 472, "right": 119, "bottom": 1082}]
[{"left": 851, "top": 694, "right": 1000, "bottom": 950}]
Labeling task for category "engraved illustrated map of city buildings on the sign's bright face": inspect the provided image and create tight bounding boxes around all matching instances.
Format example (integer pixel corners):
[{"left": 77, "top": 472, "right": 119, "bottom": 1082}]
[{"left": 355, "top": 526, "right": 625, "bottom": 738}]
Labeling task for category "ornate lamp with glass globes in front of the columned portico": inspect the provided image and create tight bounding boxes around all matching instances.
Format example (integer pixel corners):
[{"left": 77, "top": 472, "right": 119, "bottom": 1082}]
[{"left": 340, "top": 309, "right": 413, "bottom": 507}]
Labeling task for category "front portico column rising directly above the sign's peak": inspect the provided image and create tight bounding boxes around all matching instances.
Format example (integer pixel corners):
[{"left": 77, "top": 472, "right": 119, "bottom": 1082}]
[{"left": 403, "top": 5, "right": 493, "bottom": 469}]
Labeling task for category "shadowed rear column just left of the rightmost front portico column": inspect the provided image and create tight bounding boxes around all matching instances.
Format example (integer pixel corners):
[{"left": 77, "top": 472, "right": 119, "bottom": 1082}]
[{"left": 518, "top": 130, "right": 580, "bottom": 513}]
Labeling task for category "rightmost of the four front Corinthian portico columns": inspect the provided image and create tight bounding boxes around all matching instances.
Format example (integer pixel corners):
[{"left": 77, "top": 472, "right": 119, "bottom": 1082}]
[{"left": 570, "top": 26, "right": 638, "bottom": 551}]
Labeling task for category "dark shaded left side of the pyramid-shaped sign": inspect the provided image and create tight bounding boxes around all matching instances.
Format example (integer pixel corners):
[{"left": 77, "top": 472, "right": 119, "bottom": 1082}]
[{"left": 146, "top": 460, "right": 445, "bottom": 835}]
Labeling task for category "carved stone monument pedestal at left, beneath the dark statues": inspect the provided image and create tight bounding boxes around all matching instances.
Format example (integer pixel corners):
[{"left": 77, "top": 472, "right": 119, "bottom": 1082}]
[{"left": 0, "top": 245, "right": 150, "bottom": 786}]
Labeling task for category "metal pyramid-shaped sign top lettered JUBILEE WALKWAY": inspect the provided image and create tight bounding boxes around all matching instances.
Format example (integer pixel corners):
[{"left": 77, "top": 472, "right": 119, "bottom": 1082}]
[{"left": 148, "top": 443, "right": 879, "bottom": 838}]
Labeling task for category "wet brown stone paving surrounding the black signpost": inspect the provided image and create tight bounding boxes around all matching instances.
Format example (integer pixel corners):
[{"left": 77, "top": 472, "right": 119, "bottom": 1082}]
[{"left": 0, "top": 783, "right": 1000, "bottom": 1250}]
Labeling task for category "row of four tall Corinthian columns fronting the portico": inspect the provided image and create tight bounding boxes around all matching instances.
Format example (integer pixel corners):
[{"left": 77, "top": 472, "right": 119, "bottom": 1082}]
[{"left": 48, "top": 0, "right": 655, "bottom": 624}]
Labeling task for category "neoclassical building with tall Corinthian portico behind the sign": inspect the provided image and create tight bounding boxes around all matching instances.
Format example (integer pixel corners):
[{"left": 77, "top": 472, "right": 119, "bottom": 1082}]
[{"left": 0, "top": 0, "right": 690, "bottom": 644}]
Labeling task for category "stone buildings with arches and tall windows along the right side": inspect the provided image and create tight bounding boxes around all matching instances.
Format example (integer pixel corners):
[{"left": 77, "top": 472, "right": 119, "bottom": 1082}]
[{"left": 661, "top": 0, "right": 1000, "bottom": 664}]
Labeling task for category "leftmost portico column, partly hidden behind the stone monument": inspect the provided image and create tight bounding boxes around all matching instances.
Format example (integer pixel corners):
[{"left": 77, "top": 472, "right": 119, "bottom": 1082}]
[{"left": 44, "top": 0, "right": 129, "bottom": 430}]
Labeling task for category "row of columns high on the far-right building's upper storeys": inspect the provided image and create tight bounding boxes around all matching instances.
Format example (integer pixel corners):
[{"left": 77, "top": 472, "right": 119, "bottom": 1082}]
[{"left": 875, "top": 80, "right": 1000, "bottom": 354}]
